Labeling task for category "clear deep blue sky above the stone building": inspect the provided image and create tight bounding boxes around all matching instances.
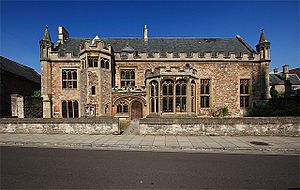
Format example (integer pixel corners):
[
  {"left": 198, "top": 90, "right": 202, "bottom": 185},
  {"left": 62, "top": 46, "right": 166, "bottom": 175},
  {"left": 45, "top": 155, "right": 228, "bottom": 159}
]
[{"left": 0, "top": 0, "right": 300, "bottom": 73}]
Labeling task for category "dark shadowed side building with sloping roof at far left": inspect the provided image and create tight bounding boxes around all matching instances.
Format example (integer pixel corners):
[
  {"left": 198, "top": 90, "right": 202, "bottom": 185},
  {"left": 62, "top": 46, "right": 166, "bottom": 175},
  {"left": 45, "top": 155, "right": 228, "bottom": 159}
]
[{"left": 0, "top": 56, "right": 41, "bottom": 117}]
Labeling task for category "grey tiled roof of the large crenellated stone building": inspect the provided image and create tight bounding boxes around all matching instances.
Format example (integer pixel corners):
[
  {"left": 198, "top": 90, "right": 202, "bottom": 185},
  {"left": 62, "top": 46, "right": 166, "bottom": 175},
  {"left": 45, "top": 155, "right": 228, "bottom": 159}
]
[{"left": 57, "top": 38, "right": 252, "bottom": 54}]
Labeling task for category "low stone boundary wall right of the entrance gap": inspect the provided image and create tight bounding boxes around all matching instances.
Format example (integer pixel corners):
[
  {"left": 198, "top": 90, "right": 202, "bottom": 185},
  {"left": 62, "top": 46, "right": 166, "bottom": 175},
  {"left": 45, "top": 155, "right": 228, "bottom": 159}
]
[{"left": 139, "top": 117, "right": 300, "bottom": 136}]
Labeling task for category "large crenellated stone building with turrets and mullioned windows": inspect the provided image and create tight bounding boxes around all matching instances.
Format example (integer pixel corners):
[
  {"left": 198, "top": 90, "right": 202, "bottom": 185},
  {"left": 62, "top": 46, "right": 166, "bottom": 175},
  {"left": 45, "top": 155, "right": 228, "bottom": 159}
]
[{"left": 40, "top": 26, "right": 270, "bottom": 120}]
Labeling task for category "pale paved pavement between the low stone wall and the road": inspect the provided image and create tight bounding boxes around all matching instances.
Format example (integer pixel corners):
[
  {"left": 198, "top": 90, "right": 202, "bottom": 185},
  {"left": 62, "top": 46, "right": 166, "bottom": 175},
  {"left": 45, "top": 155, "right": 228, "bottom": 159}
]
[{"left": 0, "top": 134, "right": 300, "bottom": 155}]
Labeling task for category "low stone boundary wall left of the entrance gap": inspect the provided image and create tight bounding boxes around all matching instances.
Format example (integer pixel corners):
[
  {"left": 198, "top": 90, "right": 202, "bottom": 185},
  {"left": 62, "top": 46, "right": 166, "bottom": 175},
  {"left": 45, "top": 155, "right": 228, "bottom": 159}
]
[{"left": 0, "top": 117, "right": 120, "bottom": 135}]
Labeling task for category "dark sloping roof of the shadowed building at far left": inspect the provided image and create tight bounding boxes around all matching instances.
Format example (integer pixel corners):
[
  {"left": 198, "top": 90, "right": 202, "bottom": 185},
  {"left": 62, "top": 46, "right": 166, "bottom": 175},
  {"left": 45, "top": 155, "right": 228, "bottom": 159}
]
[{"left": 0, "top": 56, "right": 41, "bottom": 84}]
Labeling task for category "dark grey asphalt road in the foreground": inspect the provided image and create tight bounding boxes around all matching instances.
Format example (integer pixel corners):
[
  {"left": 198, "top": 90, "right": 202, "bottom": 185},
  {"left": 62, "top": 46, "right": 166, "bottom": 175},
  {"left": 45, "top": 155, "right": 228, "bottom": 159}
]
[{"left": 0, "top": 147, "right": 300, "bottom": 189}]
